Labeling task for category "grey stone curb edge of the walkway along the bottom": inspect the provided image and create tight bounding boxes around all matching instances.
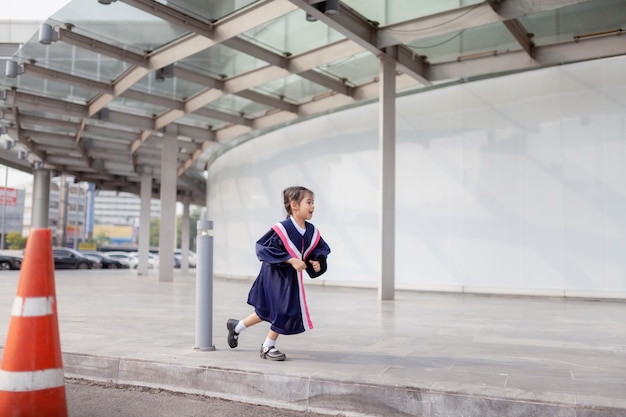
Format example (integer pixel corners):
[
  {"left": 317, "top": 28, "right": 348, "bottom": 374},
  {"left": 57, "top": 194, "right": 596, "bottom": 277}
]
[{"left": 63, "top": 353, "right": 626, "bottom": 417}]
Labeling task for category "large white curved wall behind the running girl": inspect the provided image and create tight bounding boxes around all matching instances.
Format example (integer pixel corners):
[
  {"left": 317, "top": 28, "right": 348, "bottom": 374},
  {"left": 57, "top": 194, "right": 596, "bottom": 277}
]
[{"left": 207, "top": 57, "right": 626, "bottom": 297}]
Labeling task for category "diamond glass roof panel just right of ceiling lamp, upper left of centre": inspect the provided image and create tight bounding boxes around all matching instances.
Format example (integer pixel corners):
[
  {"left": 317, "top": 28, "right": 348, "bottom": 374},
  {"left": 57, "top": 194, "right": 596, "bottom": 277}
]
[{"left": 177, "top": 44, "right": 267, "bottom": 78}]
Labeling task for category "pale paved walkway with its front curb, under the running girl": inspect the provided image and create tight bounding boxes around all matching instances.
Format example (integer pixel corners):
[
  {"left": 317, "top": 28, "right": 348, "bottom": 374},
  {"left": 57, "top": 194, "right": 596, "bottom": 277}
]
[{"left": 0, "top": 270, "right": 626, "bottom": 417}]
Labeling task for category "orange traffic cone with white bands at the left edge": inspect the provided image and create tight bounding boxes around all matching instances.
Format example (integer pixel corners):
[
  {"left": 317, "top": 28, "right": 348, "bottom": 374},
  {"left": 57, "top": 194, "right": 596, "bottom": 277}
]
[{"left": 0, "top": 229, "right": 67, "bottom": 417}]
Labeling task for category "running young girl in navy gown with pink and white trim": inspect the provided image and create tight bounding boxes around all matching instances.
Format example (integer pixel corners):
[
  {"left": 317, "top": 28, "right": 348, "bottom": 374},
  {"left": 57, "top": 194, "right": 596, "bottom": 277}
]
[{"left": 226, "top": 187, "right": 330, "bottom": 361}]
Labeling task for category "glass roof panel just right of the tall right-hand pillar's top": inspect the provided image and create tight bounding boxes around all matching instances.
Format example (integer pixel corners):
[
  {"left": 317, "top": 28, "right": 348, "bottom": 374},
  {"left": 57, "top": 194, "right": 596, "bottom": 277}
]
[{"left": 407, "top": 22, "right": 522, "bottom": 64}]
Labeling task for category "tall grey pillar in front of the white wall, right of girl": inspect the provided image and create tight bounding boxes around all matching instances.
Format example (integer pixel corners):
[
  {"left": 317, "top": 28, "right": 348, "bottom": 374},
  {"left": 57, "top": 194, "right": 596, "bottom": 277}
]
[{"left": 378, "top": 55, "right": 396, "bottom": 301}]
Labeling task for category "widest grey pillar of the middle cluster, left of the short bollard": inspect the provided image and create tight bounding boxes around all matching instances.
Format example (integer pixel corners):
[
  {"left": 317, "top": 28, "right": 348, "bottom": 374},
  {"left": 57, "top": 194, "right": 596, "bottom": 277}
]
[{"left": 159, "top": 135, "right": 178, "bottom": 282}]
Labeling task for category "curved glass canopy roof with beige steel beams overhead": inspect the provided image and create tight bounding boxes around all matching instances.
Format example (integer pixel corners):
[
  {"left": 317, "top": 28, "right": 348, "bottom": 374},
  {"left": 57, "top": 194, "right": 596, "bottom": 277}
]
[{"left": 0, "top": 0, "right": 626, "bottom": 204}]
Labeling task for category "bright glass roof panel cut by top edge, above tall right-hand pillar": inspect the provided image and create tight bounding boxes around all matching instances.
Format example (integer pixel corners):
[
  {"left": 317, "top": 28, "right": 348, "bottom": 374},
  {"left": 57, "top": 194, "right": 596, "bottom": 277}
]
[{"left": 342, "top": 0, "right": 482, "bottom": 26}]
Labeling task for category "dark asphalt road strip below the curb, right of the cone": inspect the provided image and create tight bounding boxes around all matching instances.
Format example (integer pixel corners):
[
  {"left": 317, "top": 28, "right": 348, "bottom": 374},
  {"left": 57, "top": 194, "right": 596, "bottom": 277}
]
[{"left": 65, "top": 379, "right": 342, "bottom": 417}]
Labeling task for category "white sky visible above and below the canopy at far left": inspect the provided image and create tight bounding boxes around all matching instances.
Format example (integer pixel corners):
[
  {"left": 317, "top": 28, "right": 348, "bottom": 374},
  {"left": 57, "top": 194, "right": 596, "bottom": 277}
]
[{"left": 0, "top": 0, "right": 72, "bottom": 187}]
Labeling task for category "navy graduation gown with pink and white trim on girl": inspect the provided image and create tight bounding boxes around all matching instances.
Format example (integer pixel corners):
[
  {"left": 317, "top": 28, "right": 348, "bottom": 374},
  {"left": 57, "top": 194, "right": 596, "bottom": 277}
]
[{"left": 248, "top": 218, "right": 330, "bottom": 334}]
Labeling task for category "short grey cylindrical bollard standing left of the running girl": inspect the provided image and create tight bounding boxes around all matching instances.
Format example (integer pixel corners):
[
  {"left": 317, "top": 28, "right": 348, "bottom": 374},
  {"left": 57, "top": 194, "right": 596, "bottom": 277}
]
[{"left": 194, "top": 220, "right": 215, "bottom": 351}]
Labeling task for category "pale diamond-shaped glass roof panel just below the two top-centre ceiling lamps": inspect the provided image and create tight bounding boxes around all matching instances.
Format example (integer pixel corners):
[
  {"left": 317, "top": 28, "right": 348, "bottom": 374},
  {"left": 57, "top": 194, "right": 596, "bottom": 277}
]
[{"left": 241, "top": 9, "right": 345, "bottom": 55}]
